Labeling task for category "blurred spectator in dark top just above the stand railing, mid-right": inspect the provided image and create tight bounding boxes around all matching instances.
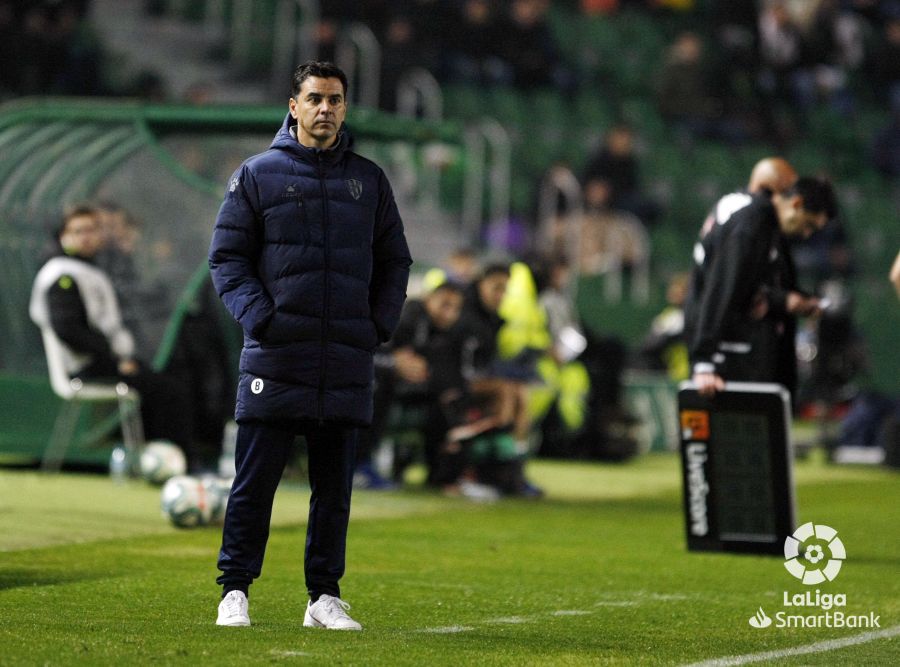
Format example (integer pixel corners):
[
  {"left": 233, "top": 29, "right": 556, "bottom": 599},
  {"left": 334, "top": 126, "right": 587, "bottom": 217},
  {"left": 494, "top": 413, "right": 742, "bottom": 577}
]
[{"left": 583, "top": 124, "right": 660, "bottom": 225}]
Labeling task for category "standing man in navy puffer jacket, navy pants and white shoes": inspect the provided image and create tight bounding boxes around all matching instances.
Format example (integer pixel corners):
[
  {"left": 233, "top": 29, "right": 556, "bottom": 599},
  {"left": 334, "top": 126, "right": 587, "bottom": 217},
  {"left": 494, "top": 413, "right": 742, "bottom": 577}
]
[{"left": 209, "top": 61, "right": 412, "bottom": 630}]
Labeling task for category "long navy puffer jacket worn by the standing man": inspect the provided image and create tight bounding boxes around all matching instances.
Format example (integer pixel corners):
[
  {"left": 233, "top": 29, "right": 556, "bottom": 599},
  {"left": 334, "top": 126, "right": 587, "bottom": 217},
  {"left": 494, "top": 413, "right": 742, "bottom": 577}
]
[{"left": 209, "top": 115, "right": 412, "bottom": 425}]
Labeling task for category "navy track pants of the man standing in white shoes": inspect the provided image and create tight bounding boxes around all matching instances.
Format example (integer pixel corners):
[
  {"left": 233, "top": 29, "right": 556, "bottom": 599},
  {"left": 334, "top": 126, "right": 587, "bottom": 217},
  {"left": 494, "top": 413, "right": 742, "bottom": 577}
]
[{"left": 216, "top": 422, "right": 358, "bottom": 600}]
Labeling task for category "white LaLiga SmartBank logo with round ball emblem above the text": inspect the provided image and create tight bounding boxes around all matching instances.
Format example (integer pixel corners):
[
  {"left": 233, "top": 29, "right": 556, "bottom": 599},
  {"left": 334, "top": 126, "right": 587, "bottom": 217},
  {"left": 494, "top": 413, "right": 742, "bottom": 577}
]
[{"left": 749, "top": 522, "right": 881, "bottom": 629}]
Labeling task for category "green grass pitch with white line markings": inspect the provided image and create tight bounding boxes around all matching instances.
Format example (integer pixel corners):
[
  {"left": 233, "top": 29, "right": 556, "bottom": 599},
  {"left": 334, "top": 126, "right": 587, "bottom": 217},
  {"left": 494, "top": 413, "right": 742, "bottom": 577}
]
[{"left": 0, "top": 455, "right": 900, "bottom": 666}]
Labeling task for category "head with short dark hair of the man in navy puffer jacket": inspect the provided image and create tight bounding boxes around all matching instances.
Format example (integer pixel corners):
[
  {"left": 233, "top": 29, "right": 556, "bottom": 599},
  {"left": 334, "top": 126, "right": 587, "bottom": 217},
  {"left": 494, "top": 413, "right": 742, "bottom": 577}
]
[{"left": 288, "top": 76, "right": 347, "bottom": 148}]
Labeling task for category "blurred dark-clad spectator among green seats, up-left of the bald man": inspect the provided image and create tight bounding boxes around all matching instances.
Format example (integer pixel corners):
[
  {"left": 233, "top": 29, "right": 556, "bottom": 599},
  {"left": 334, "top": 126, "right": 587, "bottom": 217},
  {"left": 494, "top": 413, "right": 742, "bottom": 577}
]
[{"left": 657, "top": 32, "right": 746, "bottom": 143}]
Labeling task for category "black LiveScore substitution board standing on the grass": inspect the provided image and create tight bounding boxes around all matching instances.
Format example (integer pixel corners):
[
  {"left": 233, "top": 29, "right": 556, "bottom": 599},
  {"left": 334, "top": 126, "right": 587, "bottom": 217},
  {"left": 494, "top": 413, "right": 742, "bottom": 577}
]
[{"left": 678, "top": 382, "right": 795, "bottom": 554}]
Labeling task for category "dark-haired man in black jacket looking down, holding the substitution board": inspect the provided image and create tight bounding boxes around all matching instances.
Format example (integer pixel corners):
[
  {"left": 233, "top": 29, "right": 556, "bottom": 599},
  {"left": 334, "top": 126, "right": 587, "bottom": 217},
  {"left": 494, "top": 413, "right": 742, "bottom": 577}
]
[{"left": 685, "top": 178, "right": 836, "bottom": 396}]
